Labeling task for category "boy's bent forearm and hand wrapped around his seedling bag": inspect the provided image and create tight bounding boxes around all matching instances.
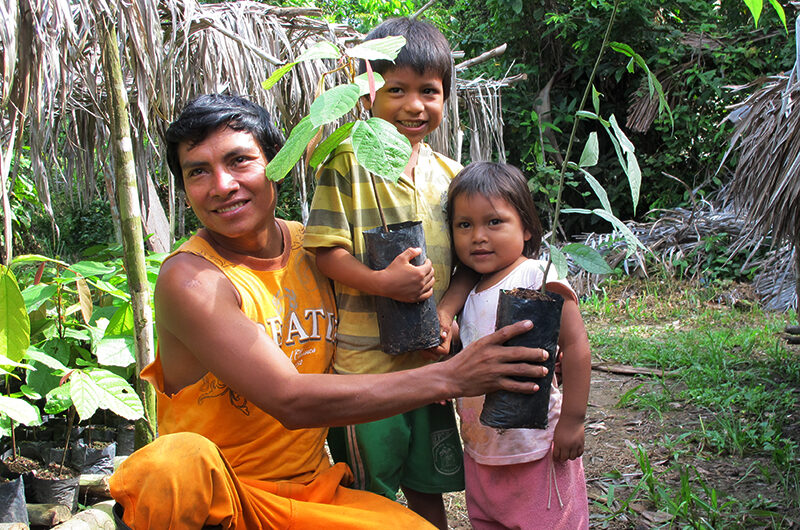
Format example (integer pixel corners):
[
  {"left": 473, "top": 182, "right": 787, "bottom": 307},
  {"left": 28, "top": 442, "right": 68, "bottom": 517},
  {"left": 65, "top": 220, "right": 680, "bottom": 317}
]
[{"left": 314, "top": 247, "right": 434, "bottom": 302}]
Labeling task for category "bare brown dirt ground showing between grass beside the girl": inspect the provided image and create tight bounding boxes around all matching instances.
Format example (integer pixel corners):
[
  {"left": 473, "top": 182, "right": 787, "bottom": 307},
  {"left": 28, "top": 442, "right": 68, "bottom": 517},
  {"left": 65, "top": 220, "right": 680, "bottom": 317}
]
[{"left": 438, "top": 364, "right": 800, "bottom": 530}]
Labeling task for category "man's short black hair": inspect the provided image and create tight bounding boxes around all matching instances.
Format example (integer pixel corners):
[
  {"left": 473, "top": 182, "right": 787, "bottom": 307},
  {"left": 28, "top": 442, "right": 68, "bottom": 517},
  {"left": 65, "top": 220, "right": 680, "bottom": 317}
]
[{"left": 165, "top": 94, "right": 283, "bottom": 189}]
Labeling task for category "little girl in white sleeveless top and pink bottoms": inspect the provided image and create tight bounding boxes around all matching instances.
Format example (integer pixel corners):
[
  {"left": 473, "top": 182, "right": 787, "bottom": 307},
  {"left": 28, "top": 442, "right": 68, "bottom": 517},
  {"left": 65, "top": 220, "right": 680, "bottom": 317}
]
[{"left": 447, "top": 162, "right": 591, "bottom": 530}]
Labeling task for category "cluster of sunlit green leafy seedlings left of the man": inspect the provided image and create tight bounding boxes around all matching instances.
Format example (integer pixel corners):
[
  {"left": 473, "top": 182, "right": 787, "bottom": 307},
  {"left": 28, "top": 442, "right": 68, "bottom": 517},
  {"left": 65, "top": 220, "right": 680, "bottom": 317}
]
[{"left": 0, "top": 250, "right": 156, "bottom": 460}]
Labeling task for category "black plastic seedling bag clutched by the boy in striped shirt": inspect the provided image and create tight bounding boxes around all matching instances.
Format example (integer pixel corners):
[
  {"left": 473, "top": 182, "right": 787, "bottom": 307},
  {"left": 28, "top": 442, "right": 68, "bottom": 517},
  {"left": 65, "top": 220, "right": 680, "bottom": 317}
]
[{"left": 364, "top": 221, "right": 440, "bottom": 355}]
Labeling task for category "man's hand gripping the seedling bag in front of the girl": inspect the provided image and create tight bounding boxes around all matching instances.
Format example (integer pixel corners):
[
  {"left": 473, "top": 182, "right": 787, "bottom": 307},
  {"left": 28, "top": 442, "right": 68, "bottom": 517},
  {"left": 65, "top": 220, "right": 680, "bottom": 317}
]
[{"left": 442, "top": 320, "right": 548, "bottom": 396}]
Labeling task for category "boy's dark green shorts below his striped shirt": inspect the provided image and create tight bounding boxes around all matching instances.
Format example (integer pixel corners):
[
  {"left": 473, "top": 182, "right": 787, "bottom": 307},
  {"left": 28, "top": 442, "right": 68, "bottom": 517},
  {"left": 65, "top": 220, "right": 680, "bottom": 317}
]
[{"left": 328, "top": 402, "right": 464, "bottom": 500}]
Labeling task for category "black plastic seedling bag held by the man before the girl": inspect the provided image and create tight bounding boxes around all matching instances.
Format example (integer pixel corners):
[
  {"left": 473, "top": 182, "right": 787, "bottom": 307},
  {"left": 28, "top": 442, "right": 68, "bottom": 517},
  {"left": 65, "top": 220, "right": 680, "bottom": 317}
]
[{"left": 480, "top": 289, "right": 564, "bottom": 429}]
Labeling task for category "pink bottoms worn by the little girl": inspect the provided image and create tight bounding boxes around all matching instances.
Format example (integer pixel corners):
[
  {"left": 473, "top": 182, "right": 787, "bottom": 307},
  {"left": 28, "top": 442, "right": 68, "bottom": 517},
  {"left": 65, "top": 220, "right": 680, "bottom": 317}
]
[{"left": 464, "top": 449, "right": 589, "bottom": 530}]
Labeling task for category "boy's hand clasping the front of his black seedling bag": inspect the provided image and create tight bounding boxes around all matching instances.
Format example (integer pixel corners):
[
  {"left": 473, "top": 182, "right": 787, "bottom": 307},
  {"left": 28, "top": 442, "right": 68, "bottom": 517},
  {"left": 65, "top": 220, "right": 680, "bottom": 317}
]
[{"left": 376, "top": 248, "right": 434, "bottom": 302}]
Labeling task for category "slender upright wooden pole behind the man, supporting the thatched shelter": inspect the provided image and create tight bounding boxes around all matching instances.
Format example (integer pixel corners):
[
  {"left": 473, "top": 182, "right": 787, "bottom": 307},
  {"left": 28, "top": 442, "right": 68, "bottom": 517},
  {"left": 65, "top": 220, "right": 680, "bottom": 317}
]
[{"left": 100, "top": 17, "right": 156, "bottom": 448}]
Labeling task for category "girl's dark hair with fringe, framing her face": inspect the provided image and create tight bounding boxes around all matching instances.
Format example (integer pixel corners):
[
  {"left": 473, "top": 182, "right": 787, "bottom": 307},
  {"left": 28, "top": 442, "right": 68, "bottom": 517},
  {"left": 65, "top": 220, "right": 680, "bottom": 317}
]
[{"left": 447, "top": 162, "right": 544, "bottom": 258}]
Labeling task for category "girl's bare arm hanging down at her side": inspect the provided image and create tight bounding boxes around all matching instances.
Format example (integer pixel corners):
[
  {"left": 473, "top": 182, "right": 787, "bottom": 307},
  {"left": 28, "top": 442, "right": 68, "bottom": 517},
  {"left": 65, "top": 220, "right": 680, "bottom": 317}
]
[{"left": 547, "top": 283, "right": 592, "bottom": 461}]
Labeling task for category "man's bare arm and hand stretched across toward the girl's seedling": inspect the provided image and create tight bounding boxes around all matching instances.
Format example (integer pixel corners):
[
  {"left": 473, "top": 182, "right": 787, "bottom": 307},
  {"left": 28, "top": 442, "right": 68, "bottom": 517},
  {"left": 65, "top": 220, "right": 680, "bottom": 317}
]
[{"left": 155, "top": 255, "right": 546, "bottom": 428}]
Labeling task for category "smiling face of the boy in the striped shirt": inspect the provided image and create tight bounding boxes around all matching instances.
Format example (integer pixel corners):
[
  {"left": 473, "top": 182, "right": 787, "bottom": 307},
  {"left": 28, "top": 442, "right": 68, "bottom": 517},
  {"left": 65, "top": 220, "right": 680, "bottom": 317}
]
[{"left": 365, "top": 66, "right": 444, "bottom": 148}]
